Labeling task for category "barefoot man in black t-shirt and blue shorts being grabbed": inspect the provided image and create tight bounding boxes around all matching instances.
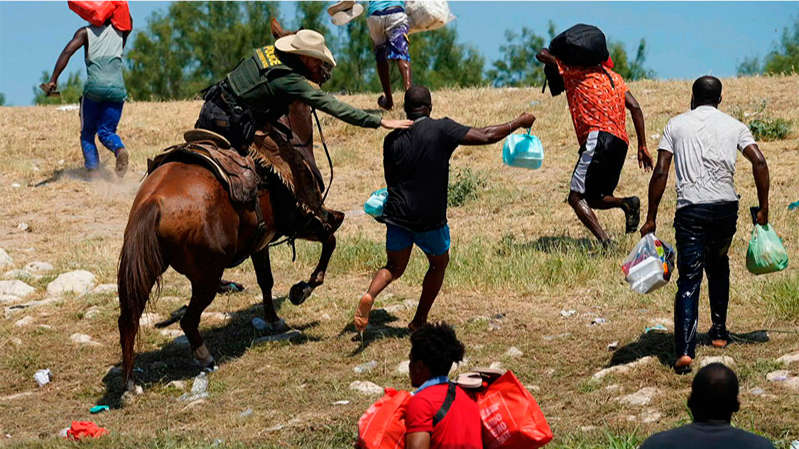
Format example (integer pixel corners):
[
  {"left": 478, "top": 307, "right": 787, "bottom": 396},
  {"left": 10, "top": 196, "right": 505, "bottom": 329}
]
[{"left": 355, "top": 86, "right": 535, "bottom": 332}]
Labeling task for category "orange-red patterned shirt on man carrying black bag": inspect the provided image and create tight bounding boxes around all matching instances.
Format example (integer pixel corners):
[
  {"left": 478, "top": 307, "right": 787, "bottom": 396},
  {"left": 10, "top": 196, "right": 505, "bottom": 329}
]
[{"left": 558, "top": 61, "right": 630, "bottom": 145}]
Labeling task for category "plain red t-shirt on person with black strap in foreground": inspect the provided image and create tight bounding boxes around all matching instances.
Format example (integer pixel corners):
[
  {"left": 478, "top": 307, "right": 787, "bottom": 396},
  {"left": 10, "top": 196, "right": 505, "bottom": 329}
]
[{"left": 405, "top": 384, "right": 483, "bottom": 449}]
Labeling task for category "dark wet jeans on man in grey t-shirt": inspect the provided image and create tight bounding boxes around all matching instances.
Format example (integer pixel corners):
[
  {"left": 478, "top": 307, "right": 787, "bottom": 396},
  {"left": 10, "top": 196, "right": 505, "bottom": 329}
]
[{"left": 674, "top": 202, "right": 738, "bottom": 358}]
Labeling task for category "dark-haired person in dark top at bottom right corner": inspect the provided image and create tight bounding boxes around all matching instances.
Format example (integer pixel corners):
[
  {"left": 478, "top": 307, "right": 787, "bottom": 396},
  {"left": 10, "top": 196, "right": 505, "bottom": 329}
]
[{"left": 640, "top": 363, "right": 774, "bottom": 449}]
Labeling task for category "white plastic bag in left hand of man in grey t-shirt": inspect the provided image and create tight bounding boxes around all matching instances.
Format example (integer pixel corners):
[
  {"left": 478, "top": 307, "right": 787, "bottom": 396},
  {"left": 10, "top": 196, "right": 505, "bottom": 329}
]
[{"left": 621, "top": 233, "right": 674, "bottom": 293}]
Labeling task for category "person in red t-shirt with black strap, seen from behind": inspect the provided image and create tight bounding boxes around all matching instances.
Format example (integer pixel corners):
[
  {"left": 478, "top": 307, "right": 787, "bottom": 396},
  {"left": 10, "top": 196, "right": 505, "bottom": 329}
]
[{"left": 405, "top": 323, "right": 483, "bottom": 449}]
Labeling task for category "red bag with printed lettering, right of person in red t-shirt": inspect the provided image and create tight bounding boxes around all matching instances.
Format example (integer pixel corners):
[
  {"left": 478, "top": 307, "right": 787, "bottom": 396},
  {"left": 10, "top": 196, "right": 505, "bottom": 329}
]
[{"left": 473, "top": 371, "right": 552, "bottom": 449}]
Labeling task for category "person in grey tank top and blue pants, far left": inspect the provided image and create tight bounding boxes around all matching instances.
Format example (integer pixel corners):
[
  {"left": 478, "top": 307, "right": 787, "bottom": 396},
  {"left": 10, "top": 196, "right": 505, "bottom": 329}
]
[{"left": 40, "top": 19, "right": 132, "bottom": 179}]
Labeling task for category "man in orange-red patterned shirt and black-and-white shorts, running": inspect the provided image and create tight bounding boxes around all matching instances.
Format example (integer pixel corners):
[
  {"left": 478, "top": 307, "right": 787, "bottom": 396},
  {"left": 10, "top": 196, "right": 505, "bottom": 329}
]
[{"left": 536, "top": 49, "right": 652, "bottom": 245}]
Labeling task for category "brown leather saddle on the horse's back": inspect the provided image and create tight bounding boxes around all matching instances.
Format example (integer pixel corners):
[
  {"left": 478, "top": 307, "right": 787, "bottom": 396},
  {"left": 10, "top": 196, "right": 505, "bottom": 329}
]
[{"left": 147, "top": 129, "right": 261, "bottom": 207}]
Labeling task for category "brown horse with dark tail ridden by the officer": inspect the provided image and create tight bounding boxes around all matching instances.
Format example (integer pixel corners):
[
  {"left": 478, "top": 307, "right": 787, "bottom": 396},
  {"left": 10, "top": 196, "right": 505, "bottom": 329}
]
[{"left": 118, "top": 20, "right": 344, "bottom": 390}]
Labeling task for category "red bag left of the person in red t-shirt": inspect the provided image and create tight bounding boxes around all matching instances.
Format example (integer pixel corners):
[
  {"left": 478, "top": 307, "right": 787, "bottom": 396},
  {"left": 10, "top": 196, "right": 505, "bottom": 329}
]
[{"left": 358, "top": 388, "right": 411, "bottom": 449}]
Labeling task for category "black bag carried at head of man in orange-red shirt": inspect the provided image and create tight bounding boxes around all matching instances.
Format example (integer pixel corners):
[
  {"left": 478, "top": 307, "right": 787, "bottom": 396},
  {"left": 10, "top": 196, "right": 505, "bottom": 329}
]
[{"left": 549, "top": 23, "right": 610, "bottom": 67}]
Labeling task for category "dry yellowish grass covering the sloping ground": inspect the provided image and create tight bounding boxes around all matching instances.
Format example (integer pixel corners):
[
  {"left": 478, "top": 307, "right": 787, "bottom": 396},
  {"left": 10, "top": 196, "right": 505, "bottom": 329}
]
[{"left": 0, "top": 77, "right": 799, "bottom": 448}]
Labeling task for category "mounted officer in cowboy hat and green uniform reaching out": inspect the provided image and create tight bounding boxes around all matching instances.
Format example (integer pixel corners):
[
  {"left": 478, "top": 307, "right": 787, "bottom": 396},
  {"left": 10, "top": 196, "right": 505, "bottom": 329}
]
[{"left": 195, "top": 30, "right": 411, "bottom": 154}]
